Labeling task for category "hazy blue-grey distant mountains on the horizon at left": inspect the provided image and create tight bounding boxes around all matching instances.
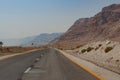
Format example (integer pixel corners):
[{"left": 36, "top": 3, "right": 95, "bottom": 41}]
[{"left": 0, "top": 33, "right": 63, "bottom": 46}]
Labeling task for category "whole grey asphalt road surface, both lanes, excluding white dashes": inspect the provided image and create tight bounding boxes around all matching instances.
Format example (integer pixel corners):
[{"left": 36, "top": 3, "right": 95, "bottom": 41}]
[{"left": 0, "top": 49, "right": 98, "bottom": 80}]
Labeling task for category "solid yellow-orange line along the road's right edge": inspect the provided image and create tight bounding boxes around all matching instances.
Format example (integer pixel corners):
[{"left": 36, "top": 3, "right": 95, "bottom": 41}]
[{"left": 56, "top": 49, "right": 105, "bottom": 80}]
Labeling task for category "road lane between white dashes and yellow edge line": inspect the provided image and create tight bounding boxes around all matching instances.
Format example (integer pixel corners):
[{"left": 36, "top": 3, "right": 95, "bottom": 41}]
[{"left": 22, "top": 49, "right": 99, "bottom": 80}]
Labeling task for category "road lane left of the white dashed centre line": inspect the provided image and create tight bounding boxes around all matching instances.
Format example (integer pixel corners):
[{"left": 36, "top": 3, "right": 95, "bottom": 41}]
[{"left": 0, "top": 51, "right": 43, "bottom": 80}]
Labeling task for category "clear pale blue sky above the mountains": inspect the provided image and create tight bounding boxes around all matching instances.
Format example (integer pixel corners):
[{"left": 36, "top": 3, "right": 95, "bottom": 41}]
[{"left": 0, "top": 0, "right": 120, "bottom": 39}]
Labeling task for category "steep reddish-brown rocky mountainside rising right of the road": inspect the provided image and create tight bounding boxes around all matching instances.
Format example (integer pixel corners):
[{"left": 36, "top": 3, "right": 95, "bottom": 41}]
[{"left": 54, "top": 4, "right": 120, "bottom": 48}]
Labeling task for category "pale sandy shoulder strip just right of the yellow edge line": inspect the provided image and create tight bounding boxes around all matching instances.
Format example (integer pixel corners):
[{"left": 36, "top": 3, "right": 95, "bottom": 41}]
[{"left": 57, "top": 51, "right": 120, "bottom": 80}]
